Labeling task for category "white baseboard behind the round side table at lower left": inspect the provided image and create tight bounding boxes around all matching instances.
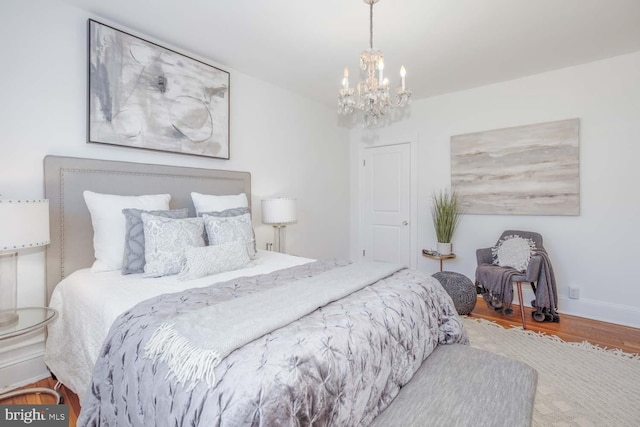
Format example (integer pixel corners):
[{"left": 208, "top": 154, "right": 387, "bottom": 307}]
[{"left": 0, "top": 337, "right": 51, "bottom": 393}]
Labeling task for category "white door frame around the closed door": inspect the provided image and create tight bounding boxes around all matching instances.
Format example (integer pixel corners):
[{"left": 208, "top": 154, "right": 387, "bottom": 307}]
[{"left": 350, "top": 136, "right": 420, "bottom": 269}]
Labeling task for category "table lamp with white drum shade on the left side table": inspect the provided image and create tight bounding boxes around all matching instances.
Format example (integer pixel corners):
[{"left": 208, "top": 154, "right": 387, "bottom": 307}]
[{"left": 0, "top": 198, "right": 49, "bottom": 327}]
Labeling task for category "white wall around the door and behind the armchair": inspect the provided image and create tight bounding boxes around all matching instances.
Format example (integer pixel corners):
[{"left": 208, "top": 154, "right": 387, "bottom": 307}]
[{"left": 351, "top": 52, "right": 640, "bottom": 327}]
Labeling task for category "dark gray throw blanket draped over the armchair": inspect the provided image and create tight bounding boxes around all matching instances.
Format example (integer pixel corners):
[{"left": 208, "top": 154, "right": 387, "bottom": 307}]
[{"left": 476, "top": 249, "right": 558, "bottom": 321}]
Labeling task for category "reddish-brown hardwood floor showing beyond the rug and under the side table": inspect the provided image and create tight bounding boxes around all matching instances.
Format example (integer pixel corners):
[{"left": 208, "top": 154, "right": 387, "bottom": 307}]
[{"left": 2, "top": 298, "right": 640, "bottom": 426}]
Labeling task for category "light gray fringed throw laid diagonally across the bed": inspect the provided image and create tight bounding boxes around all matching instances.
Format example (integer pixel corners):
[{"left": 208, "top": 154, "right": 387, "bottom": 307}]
[{"left": 145, "top": 262, "right": 404, "bottom": 388}]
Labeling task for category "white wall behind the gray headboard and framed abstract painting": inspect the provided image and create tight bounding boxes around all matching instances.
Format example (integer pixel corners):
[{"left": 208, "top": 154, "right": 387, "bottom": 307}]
[{"left": 0, "top": 0, "right": 349, "bottom": 389}]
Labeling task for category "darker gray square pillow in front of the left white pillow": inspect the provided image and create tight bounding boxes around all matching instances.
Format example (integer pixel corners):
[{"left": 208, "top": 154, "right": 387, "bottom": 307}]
[{"left": 122, "top": 208, "right": 189, "bottom": 274}]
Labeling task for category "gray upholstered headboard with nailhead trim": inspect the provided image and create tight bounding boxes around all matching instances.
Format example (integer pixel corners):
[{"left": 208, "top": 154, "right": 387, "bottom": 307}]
[{"left": 44, "top": 156, "right": 251, "bottom": 302}]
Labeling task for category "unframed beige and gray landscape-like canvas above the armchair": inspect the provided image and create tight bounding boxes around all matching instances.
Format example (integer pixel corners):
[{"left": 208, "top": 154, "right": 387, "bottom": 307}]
[{"left": 451, "top": 119, "right": 580, "bottom": 215}]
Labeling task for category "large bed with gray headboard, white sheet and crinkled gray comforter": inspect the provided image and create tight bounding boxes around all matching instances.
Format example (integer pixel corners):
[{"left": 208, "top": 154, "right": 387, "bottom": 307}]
[{"left": 45, "top": 156, "right": 467, "bottom": 426}]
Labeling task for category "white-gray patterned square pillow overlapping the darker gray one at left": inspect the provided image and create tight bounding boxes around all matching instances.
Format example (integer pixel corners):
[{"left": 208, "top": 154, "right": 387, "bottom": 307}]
[{"left": 141, "top": 213, "right": 204, "bottom": 277}]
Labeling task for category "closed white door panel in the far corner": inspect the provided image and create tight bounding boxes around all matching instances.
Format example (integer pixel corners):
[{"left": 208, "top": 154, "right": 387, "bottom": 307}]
[{"left": 362, "top": 143, "right": 412, "bottom": 266}]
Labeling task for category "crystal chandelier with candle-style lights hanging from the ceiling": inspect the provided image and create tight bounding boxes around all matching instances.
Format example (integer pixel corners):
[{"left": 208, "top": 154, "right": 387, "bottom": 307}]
[{"left": 338, "top": 0, "right": 411, "bottom": 126}]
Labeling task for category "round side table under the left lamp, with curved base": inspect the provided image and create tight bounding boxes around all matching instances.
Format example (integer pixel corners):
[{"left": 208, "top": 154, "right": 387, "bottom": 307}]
[{"left": 0, "top": 307, "right": 62, "bottom": 405}]
